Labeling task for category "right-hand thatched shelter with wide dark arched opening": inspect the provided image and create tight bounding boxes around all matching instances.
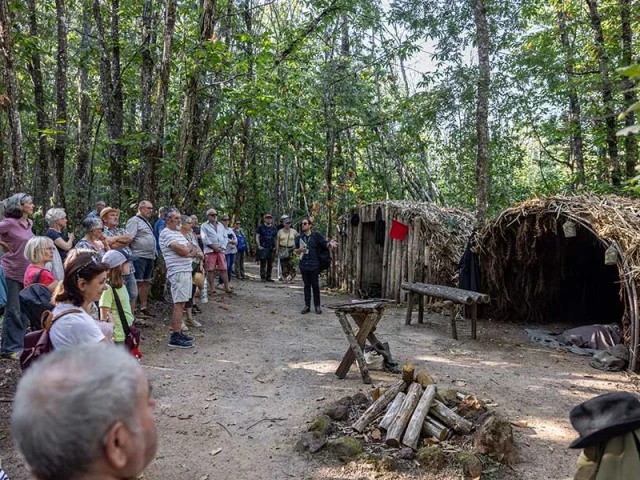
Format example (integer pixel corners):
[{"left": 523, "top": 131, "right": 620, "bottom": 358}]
[{"left": 478, "top": 195, "right": 640, "bottom": 370}]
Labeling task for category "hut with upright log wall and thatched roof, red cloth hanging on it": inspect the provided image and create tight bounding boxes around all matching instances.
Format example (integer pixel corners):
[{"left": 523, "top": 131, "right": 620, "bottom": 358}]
[{"left": 329, "top": 201, "right": 474, "bottom": 301}]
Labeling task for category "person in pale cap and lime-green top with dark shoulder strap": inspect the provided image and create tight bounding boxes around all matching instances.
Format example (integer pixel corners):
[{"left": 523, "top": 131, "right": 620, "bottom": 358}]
[{"left": 99, "top": 249, "right": 133, "bottom": 345}]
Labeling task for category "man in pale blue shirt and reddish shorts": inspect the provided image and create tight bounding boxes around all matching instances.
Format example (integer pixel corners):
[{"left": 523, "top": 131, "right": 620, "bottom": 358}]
[{"left": 200, "top": 208, "right": 231, "bottom": 293}]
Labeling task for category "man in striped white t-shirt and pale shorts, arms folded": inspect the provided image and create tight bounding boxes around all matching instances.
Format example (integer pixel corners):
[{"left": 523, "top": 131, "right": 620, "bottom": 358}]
[{"left": 160, "top": 208, "right": 198, "bottom": 348}]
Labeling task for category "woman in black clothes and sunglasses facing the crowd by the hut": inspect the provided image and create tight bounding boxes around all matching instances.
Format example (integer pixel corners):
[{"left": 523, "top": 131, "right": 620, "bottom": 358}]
[{"left": 295, "top": 218, "right": 328, "bottom": 315}]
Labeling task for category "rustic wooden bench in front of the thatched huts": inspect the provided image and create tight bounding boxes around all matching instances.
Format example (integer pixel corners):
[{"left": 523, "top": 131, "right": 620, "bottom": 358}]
[{"left": 402, "top": 282, "right": 489, "bottom": 340}]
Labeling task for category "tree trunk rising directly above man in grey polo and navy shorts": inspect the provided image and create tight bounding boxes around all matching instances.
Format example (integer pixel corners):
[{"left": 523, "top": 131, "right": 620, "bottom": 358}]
[{"left": 144, "top": 0, "right": 177, "bottom": 203}]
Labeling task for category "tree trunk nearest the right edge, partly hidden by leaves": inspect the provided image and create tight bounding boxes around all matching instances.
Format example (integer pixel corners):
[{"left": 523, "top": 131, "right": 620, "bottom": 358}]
[{"left": 620, "top": 0, "right": 638, "bottom": 178}]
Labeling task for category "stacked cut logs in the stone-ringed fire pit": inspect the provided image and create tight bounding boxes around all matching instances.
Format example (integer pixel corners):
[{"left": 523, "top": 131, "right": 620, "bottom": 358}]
[{"left": 353, "top": 364, "right": 473, "bottom": 450}]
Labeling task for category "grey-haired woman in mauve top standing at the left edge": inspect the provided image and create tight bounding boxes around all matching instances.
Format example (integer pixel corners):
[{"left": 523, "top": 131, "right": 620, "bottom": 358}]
[{"left": 0, "top": 193, "right": 34, "bottom": 359}]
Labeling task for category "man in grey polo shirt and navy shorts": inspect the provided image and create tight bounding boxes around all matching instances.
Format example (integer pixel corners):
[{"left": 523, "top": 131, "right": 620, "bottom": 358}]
[{"left": 126, "top": 200, "right": 156, "bottom": 318}]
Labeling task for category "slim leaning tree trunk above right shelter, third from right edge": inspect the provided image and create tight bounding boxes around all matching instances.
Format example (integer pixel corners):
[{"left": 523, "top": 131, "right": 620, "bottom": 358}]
[{"left": 557, "top": 6, "right": 585, "bottom": 187}]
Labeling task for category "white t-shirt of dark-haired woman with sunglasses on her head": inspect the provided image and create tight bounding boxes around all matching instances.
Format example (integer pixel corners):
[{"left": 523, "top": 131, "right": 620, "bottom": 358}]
[{"left": 49, "top": 303, "right": 105, "bottom": 348}]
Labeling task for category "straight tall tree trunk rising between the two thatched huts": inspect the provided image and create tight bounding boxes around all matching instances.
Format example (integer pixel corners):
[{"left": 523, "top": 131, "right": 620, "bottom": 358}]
[{"left": 474, "top": 0, "right": 490, "bottom": 227}]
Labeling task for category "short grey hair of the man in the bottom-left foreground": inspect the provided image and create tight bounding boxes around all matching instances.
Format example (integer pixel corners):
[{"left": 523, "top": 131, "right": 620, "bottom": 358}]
[{"left": 11, "top": 344, "right": 144, "bottom": 480}]
